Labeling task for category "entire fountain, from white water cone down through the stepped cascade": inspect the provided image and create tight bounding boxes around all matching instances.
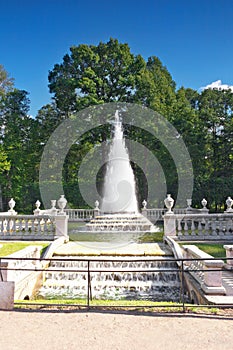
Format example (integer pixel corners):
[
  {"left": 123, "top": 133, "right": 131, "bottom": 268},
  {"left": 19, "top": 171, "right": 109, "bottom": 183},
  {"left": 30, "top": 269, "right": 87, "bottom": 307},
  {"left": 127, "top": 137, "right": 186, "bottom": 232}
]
[{"left": 36, "top": 111, "right": 180, "bottom": 301}]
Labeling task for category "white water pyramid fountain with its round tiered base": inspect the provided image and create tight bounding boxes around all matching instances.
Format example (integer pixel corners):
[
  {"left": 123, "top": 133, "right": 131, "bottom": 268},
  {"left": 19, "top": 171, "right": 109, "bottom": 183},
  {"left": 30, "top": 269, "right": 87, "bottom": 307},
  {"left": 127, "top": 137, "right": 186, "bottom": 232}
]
[{"left": 86, "top": 111, "right": 156, "bottom": 232}]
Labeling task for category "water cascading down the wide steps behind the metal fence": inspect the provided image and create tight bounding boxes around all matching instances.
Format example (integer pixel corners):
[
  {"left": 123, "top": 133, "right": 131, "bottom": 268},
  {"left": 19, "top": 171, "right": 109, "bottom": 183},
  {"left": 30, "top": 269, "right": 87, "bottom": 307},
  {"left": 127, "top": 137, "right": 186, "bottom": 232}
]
[{"left": 39, "top": 257, "right": 181, "bottom": 301}]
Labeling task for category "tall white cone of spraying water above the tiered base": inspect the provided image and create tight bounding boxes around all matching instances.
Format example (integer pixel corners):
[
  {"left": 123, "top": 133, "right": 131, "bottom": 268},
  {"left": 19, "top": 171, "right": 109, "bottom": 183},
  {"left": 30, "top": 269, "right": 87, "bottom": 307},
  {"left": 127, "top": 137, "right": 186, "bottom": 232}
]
[{"left": 101, "top": 111, "right": 138, "bottom": 213}]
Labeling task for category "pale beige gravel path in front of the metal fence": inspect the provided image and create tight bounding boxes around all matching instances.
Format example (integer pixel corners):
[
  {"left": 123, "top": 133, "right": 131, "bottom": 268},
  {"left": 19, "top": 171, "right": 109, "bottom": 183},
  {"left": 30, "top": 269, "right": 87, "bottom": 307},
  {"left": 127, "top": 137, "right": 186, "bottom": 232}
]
[{"left": 0, "top": 311, "right": 233, "bottom": 350}]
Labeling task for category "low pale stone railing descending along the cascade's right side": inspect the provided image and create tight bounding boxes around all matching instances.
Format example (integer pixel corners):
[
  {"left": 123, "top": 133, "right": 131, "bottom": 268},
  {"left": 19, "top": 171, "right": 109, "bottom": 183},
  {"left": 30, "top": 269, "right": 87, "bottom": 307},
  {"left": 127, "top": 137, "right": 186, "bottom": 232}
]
[{"left": 183, "top": 245, "right": 226, "bottom": 295}]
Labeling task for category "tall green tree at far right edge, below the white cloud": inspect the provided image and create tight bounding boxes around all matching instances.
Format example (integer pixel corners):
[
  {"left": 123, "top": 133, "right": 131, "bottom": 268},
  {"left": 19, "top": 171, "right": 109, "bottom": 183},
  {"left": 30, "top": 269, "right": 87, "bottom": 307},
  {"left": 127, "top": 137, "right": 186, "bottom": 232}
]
[{"left": 198, "top": 89, "right": 233, "bottom": 210}]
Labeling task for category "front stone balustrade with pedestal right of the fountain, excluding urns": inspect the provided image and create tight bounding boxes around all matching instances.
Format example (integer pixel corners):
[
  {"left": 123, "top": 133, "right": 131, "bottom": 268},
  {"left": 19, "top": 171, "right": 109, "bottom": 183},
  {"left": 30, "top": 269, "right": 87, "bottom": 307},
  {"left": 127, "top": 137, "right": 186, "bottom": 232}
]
[{"left": 164, "top": 213, "right": 233, "bottom": 240}]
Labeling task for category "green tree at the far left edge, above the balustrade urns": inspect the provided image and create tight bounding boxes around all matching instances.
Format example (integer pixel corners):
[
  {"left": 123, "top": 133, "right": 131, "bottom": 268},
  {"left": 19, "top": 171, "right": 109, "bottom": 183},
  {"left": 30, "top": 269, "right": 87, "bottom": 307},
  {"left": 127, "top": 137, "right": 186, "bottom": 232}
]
[{"left": 1, "top": 89, "right": 35, "bottom": 211}]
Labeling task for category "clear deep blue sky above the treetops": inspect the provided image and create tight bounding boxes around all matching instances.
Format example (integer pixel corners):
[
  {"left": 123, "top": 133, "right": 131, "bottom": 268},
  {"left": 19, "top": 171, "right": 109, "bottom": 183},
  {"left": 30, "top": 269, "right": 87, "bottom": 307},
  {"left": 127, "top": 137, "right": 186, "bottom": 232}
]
[{"left": 0, "top": 0, "right": 233, "bottom": 116}]
